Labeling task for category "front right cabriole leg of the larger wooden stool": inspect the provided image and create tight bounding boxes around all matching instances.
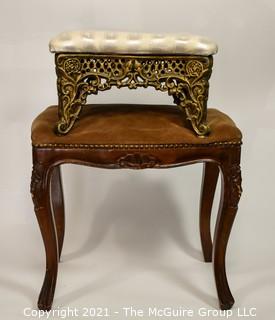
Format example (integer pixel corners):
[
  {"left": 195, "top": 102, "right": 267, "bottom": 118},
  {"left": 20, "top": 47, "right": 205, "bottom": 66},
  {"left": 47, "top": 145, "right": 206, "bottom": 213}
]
[{"left": 213, "top": 154, "right": 242, "bottom": 310}]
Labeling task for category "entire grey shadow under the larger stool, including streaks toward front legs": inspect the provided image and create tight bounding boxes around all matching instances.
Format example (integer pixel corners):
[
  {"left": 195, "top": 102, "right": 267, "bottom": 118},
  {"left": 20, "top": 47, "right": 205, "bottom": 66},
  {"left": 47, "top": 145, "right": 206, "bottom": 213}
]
[{"left": 56, "top": 175, "right": 220, "bottom": 307}]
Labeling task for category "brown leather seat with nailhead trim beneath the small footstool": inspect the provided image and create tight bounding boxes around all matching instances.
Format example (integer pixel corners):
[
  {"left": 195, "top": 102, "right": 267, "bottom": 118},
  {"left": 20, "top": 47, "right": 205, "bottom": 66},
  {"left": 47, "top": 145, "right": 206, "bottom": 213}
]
[{"left": 32, "top": 104, "right": 242, "bottom": 147}]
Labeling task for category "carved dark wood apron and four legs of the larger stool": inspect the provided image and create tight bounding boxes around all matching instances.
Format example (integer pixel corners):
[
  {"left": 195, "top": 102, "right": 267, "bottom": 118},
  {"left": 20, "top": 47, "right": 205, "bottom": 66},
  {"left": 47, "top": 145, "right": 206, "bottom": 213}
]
[{"left": 31, "top": 144, "right": 241, "bottom": 310}]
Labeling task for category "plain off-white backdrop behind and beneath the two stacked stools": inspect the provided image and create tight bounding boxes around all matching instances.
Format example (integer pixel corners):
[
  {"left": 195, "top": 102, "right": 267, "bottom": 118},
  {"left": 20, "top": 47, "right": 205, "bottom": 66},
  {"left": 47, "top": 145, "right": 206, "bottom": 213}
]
[{"left": 0, "top": 0, "right": 275, "bottom": 319}]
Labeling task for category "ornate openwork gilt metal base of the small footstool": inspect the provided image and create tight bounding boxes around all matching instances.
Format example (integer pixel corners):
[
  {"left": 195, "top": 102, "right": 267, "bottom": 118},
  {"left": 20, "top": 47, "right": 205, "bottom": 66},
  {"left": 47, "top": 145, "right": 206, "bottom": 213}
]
[{"left": 55, "top": 53, "right": 213, "bottom": 136}]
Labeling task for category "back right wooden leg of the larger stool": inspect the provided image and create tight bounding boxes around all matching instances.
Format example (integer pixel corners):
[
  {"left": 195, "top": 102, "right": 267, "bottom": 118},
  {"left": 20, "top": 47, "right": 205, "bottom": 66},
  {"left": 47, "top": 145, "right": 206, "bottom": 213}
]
[{"left": 200, "top": 162, "right": 219, "bottom": 262}]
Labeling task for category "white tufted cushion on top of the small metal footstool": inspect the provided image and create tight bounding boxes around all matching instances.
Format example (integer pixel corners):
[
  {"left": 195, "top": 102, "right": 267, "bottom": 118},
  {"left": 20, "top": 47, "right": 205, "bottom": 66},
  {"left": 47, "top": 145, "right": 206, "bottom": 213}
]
[{"left": 49, "top": 31, "right": 218, "bottom": 56}]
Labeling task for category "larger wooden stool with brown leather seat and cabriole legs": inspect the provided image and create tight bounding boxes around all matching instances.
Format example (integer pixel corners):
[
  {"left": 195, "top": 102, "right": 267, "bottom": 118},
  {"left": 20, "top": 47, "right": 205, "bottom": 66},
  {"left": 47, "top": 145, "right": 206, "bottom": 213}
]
[{"left": 31, "top": 102, "right": 242, "bottom": 310}]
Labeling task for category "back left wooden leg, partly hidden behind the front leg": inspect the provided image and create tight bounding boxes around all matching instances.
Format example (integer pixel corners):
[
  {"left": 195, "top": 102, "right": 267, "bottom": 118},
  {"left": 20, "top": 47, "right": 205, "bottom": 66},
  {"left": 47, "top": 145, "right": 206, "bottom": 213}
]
[{"left": 51, "top": 166, "right": 65, "bottom": 260}]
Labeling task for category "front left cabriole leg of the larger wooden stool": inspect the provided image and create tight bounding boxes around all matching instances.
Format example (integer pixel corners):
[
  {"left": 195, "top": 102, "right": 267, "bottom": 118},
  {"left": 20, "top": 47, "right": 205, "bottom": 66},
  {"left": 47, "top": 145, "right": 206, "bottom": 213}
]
[{"left": 31, "top": 158, "right": 58, "bottom": 310}]
